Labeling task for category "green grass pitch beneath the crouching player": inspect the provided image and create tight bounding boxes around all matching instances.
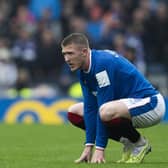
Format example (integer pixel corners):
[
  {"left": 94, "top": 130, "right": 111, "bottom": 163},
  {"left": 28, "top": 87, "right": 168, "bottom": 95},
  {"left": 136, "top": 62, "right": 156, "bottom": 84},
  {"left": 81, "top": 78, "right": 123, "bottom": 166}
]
[{"left": 0, "top": 124, "right": 168, "bottom": 168}]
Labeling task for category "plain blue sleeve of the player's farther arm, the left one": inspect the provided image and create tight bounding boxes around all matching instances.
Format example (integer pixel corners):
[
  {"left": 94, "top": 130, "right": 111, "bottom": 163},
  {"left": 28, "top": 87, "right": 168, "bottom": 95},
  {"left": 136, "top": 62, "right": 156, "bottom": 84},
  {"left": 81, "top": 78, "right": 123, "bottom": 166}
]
[{"left": 81, "top": 80, "right": 98, "bottom": 144}]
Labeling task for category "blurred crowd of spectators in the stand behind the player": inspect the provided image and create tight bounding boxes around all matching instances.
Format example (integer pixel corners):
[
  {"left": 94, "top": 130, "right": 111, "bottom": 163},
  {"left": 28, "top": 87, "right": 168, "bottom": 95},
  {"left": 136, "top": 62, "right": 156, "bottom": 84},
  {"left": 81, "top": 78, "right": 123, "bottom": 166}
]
[{"left": 0, "top": 0, "right": 168, "bottom": 97}]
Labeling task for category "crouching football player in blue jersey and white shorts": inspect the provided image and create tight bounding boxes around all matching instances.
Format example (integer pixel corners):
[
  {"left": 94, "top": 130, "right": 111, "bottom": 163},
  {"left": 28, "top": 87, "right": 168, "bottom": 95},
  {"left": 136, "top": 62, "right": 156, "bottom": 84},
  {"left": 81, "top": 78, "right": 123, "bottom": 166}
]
[{"left": 61, "top": 33, "right": 165, "bottom": 163}]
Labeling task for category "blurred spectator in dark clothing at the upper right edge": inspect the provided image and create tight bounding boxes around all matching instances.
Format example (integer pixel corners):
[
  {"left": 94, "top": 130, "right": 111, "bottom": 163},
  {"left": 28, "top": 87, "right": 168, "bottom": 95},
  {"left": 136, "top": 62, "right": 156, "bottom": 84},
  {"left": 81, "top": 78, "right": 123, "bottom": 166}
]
[{"left": 145, "top": 2, "right": 168, "bottom": 65}]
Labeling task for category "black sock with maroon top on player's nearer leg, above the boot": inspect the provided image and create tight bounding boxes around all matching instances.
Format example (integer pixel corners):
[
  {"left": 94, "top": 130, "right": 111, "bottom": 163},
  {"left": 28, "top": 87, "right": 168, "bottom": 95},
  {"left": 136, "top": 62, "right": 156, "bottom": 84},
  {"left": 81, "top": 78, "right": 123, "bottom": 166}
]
[{"left": 105, "top": 118, "right": 140, "bottom": 143}]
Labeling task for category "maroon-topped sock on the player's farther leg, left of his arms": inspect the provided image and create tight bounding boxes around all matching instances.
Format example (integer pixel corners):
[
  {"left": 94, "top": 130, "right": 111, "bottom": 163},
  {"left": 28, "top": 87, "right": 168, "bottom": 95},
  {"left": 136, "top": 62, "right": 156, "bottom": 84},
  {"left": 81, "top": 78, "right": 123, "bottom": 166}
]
[{"left": 67, "top": 112, "right": 85, "bottom": 129}]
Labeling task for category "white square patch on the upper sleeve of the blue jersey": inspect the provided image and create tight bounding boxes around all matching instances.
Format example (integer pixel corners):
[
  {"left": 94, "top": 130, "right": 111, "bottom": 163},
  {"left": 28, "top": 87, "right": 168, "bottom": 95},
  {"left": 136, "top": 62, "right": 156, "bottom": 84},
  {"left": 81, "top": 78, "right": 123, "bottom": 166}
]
[{"left": 96, "top": 70, "right": 110, "bottom": 88}]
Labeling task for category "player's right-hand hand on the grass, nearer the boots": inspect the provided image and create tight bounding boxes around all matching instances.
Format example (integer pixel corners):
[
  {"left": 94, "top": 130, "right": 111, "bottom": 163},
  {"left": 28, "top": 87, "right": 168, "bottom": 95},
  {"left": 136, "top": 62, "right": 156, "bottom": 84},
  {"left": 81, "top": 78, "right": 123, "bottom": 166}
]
[{"left": 91, "top": 149, "right": 105, "bottom": 163}]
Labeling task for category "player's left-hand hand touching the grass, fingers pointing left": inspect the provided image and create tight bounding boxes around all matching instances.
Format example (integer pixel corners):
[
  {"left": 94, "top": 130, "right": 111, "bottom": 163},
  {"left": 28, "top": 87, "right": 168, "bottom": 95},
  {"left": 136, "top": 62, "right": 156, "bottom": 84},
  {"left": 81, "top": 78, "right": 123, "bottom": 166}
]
[{"left": 75, "top": 146, "right": 93, "bottom": 163}]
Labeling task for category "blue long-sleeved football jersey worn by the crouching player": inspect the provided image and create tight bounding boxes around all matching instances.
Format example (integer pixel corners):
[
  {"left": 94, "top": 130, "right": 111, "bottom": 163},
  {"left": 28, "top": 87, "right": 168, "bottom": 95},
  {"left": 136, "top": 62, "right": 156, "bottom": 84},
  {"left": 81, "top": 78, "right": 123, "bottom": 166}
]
[{"left": 79, "top": 50, "right": 158, "bottom": 148}]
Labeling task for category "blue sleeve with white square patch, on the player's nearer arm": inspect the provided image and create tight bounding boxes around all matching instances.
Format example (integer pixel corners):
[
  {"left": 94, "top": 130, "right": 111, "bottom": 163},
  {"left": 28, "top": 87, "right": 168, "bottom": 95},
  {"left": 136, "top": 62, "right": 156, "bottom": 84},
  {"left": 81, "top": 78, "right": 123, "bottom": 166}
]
[{"left": 96, "top": 57, "right": 114, "bottom": 148}]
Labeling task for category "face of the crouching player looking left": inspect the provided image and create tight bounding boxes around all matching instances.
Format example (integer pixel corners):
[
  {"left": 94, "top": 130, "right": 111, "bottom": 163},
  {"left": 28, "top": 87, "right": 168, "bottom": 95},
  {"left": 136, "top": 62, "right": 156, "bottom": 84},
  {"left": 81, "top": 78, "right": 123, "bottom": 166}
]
[{"left": 62, "top": 44, "right": 86, "bottom": 71}]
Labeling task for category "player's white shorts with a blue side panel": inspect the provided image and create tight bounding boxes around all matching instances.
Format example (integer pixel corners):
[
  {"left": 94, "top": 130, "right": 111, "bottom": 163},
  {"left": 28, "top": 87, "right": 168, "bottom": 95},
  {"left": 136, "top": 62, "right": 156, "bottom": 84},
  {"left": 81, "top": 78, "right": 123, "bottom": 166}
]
[{"left": 121, "top": 94, "right": 166, "bottom": 128}]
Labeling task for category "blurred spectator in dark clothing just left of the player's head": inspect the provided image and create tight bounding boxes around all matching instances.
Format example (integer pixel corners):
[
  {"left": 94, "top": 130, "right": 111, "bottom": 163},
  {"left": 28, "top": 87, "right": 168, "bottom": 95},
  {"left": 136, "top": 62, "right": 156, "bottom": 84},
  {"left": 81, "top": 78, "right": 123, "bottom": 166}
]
[{"left": 35, "top": 28, "right": 63, "bottom": 82}]
